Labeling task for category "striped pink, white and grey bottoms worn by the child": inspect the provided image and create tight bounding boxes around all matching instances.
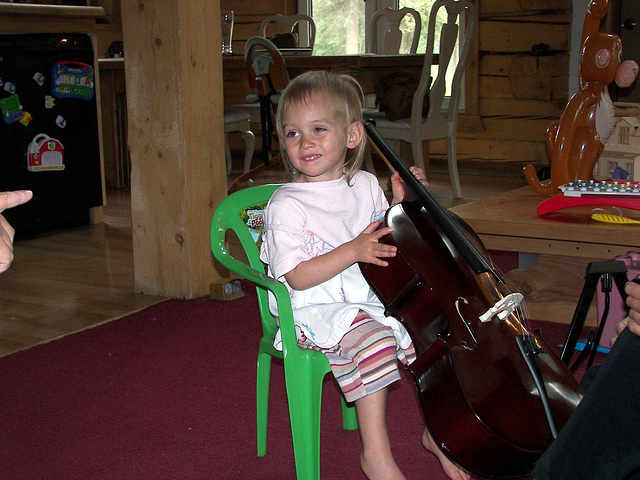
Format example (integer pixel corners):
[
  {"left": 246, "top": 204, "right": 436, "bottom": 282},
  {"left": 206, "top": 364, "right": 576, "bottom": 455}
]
[{"left": 300, "top": 311, "right": 416, "bottom": 402}]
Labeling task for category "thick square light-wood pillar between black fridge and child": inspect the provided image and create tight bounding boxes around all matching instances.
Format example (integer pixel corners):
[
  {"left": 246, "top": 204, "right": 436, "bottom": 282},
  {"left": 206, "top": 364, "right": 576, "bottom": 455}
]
[{"left": 121, "top": 0, "right": 227, "bottom": 298}]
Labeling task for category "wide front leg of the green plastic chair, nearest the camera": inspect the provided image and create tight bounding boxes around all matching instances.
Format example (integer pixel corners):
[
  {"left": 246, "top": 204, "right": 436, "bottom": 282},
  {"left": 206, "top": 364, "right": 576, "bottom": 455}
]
[{"left": 285, "top": 367, "right": 322, "bottom": 480}]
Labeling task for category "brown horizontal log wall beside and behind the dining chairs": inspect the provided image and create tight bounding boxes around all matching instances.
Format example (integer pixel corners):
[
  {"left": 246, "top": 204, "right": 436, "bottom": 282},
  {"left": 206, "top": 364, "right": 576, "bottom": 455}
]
[{"left": 221, "top": 0, "right": 571, "bottom": 175}]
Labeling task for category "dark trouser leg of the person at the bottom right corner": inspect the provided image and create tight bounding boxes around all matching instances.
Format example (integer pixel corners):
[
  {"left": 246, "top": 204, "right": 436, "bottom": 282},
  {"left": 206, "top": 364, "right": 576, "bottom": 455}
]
[{"left": 532, "top": 329, "right": 640, "bottom": 480}]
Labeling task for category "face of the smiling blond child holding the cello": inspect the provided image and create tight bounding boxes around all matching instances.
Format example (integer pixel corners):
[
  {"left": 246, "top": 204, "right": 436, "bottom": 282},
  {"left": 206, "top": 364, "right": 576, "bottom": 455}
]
[{"left": 282, "top": 93, "right": 362, "bottom": 182}]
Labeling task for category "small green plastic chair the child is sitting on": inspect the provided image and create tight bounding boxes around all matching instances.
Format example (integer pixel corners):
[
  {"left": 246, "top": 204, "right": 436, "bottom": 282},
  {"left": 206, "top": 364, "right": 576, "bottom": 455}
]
[{"left": 211, "top": 185, "right": 358, "bottom": 480}]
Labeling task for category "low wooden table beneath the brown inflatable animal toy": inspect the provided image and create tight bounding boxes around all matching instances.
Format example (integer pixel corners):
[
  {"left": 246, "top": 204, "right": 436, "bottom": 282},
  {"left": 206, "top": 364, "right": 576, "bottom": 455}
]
[{"left": 451, "top": 187, "right": 640, "bottom": 325}]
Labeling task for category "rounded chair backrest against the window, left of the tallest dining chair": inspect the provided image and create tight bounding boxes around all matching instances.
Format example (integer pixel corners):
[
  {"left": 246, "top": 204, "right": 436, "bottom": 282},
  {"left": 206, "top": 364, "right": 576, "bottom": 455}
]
[{"left": 367, "top": 7, "right": 422, "bottom": 55}]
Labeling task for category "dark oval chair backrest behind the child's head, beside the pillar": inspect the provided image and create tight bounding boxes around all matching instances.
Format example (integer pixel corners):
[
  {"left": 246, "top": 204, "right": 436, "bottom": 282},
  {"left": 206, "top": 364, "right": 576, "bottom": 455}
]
[{"left": 244, "top": 37, "right": 289, "bottom": 96}]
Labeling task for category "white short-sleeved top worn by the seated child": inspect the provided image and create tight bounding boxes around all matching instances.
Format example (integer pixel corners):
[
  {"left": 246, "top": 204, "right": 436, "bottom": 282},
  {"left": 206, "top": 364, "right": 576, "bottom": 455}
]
[{"left": 260, "top": 171, "right": 411, "bottom": 349}]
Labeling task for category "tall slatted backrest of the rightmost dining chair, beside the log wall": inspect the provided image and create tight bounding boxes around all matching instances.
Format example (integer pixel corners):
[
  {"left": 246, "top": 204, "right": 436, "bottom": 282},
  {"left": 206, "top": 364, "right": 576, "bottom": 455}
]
[{"left": 411, "top": 0, "right": 476, "bottom": 122}]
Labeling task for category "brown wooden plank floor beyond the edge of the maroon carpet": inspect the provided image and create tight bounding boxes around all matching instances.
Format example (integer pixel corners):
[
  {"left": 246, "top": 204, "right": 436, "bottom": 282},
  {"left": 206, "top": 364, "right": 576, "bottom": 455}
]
[{"left": 0, "top": 162, "right": 525, "bottom": 356}]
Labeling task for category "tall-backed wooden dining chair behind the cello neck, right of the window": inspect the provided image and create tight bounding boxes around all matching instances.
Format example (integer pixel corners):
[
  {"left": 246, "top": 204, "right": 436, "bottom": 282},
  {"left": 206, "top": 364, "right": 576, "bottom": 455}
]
[{"left": 368, "top": 0, "right": 476, "bottom": 198}]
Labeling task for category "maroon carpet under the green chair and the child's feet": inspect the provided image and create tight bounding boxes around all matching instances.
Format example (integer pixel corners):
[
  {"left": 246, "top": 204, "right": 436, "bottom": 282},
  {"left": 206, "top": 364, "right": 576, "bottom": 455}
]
[{"left": 0, "top": 280, "right": 600, "bottom": 480}]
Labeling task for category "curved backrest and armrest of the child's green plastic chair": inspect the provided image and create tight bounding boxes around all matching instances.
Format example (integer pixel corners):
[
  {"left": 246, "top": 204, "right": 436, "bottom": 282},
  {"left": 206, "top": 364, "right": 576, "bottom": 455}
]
[{"left": 211, "top": 185, "right": 282, "bottom": 335}]
